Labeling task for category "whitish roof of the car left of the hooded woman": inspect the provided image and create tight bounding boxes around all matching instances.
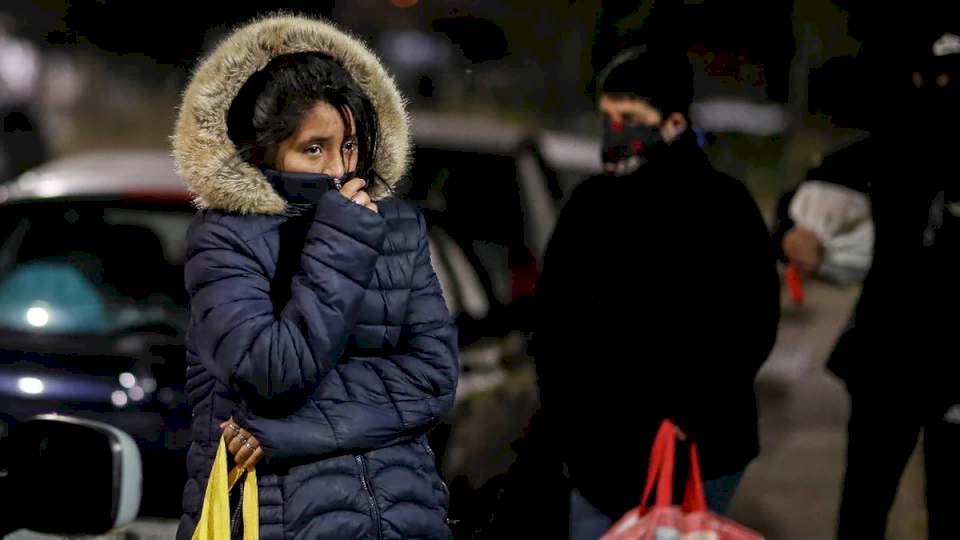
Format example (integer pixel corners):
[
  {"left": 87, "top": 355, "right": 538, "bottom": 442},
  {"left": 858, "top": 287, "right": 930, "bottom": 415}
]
[{"left": 0, "top": 150, "right": 190, "bottom": 204}]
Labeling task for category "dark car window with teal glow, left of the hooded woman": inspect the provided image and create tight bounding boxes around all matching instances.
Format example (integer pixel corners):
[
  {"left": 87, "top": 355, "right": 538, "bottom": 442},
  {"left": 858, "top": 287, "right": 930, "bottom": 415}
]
[{"left": 0, "top": 201, "right": 193, "bottom": 335}]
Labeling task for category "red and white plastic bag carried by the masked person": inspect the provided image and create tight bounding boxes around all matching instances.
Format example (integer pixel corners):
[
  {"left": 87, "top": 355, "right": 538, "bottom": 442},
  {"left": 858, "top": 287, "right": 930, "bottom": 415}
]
[{"left": 601, "top": 420, "right": 763, "bottom": 540}]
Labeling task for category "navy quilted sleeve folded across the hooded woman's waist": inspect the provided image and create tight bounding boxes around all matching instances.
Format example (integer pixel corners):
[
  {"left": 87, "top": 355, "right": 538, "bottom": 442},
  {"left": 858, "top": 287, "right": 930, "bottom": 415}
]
[{"left": 237, "top": 209, "right": 460, "bottom": 460}]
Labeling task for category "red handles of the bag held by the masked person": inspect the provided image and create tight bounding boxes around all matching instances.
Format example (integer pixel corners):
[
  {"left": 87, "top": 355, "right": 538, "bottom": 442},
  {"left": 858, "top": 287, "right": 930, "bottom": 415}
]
[{"left": 639, "top": 420, "right": 707, "bottom": 514}]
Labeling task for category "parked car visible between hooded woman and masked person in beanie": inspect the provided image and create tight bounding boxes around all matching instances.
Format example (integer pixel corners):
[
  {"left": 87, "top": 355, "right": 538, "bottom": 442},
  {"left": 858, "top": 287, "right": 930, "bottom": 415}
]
[{"left": 404, "top": 114, "right": 601, "bottom": 344}]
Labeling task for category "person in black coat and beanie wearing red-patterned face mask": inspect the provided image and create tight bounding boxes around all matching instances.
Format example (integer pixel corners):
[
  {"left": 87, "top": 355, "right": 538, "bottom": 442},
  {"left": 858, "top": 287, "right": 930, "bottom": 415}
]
[{"left": 533, "top": 47, "right": 780, "bottom": 540}]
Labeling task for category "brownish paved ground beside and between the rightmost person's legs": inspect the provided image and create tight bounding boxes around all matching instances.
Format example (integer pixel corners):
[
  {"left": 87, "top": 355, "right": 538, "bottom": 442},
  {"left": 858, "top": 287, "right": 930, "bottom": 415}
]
[{"left": 730, "top": 276, "right": 926, "bottom": 540}]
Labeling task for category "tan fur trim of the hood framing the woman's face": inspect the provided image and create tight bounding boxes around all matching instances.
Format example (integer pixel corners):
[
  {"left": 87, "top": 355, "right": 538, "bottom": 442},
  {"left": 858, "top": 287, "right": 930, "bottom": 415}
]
[{"left": 172, "top": 15, "right": 411, "bottom": 214}]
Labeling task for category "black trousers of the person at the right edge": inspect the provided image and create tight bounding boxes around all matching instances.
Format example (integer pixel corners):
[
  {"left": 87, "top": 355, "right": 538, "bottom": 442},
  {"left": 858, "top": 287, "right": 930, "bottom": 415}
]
[{"left": 838, "top": 387, "right": 960, "bottom": 540}]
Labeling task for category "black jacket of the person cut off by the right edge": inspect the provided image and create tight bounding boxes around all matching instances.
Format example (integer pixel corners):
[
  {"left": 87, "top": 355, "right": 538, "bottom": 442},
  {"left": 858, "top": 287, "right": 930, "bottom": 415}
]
[{"left": 774, "top": 134, "right": 960, "bottom": 394}]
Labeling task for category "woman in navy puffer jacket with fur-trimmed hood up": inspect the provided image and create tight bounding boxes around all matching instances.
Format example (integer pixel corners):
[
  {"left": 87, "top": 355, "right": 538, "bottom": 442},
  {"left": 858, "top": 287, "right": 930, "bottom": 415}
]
[{"left": 173, "top": 12, "right": 459, "bottom": 540}]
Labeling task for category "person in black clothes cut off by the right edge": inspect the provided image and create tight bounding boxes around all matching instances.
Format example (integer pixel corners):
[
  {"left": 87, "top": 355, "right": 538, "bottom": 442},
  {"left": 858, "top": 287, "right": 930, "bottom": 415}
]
[{"left": 778, "top": 34, "right": 960, "bottom": 539}]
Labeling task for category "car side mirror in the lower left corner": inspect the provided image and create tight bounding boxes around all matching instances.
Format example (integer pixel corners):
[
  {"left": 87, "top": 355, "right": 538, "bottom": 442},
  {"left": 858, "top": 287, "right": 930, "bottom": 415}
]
[{"left": 0, "top": 414, "right": 143, "bottom": 536}]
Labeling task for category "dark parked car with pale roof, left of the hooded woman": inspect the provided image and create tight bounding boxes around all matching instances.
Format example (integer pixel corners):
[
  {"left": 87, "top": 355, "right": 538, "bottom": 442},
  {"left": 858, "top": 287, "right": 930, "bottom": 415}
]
[{"left": 0, "top": 152, "right": 194, "bottom": 517}]
